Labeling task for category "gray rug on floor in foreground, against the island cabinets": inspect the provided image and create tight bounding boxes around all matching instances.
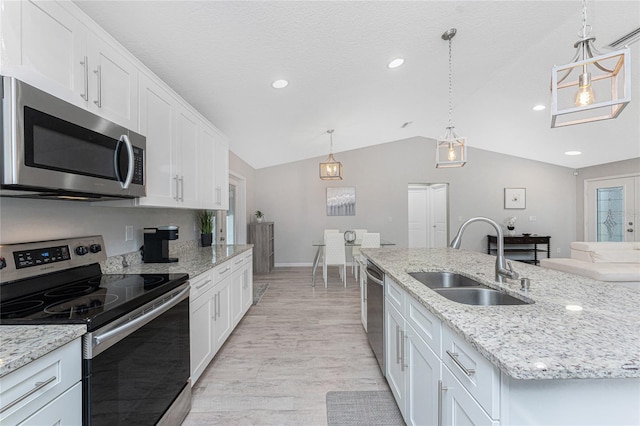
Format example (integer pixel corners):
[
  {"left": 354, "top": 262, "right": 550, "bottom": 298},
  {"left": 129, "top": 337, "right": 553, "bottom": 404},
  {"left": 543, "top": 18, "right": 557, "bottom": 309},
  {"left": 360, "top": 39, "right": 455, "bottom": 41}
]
[{"left": 327, "top": 391, "right": 405, "bottom": 426}]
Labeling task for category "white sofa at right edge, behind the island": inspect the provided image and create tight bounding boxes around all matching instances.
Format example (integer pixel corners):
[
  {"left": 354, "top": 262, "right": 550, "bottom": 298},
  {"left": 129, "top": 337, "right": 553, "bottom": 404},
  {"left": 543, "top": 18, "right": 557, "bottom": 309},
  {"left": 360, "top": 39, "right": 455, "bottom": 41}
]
[{"left": 540, "top": 241, "right": 640, "bottom": 289}]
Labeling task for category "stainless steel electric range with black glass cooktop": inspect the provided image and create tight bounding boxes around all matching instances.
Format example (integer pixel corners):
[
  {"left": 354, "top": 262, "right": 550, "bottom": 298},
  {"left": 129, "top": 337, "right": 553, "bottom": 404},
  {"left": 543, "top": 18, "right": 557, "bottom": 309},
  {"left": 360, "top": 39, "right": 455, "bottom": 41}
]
[{"left": 0, "top": 236, "right": 191, "bottom": 425}]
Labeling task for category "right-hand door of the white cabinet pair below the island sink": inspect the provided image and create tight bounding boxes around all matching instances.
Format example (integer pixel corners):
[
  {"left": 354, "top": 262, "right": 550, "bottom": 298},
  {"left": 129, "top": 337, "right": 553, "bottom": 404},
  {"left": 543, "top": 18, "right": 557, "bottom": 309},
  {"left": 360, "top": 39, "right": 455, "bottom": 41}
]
[{"left": 405, "top": 324, "right": 440, "bottom": 425}]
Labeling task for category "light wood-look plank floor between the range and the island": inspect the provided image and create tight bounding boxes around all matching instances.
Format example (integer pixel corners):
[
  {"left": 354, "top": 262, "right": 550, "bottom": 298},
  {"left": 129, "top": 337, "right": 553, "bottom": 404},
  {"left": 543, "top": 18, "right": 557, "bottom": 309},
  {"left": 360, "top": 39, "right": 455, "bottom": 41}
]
[{"left": 183, "top": 267, "right": 388, "bottom": 425}]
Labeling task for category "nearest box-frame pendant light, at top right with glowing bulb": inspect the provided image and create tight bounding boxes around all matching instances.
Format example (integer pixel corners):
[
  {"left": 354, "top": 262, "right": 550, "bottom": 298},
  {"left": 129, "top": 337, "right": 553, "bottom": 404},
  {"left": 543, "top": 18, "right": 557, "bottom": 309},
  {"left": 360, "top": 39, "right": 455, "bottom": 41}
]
[{"left": 551, "top": 0, "right": 631, "bottom": 128}]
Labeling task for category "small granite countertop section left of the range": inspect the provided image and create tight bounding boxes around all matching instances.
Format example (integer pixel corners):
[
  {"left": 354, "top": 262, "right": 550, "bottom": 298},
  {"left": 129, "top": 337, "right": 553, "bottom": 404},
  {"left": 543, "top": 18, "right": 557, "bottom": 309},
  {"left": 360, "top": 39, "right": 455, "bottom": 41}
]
[{"left": 0, "top": 324, "right": 87, "bottom": 377}]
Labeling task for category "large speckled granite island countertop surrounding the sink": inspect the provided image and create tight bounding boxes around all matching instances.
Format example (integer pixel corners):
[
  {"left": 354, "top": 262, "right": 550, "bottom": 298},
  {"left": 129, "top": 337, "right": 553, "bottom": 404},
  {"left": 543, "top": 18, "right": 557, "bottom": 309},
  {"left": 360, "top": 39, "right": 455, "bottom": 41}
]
[{"left": 362, "top": 247, "right": 640, "bottom": 379}]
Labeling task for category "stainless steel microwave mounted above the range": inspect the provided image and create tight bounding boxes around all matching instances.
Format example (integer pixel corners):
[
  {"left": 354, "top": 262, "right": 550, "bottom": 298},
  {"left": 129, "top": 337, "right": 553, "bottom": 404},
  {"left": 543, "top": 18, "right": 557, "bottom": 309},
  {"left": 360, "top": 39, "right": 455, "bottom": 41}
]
[{"left": 0, "top": 77, "right": 146, "bottom": 200}]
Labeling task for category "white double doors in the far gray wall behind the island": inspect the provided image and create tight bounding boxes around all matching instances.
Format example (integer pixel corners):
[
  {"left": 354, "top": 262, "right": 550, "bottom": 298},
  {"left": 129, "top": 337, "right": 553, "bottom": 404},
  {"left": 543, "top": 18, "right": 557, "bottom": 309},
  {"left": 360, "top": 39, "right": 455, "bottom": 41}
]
[{"left": 407, "top": 183, "right": 449, "bottom": 248}]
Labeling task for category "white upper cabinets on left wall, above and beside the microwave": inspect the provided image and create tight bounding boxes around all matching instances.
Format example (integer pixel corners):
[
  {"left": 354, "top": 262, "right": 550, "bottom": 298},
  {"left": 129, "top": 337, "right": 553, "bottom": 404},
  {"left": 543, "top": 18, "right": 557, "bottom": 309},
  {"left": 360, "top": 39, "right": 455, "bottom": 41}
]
[{"left": 0, "top": 0, "right": 229, "bottom": 210}]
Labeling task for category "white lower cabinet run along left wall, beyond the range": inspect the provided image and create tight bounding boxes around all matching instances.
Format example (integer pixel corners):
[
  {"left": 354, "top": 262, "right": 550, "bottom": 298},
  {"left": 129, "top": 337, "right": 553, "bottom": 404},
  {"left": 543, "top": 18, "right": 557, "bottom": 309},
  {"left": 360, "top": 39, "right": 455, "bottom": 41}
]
[{"left": 189, "top": 251, "right": 253, "bottom": 386}]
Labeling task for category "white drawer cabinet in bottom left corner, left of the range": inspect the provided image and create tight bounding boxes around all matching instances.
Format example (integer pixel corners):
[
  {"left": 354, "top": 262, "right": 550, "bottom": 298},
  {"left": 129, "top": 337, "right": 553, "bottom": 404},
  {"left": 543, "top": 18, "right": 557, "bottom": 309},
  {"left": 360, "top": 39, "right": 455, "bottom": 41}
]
[{"left": 0, "top": 338, "right": 82, "bottom": 426}]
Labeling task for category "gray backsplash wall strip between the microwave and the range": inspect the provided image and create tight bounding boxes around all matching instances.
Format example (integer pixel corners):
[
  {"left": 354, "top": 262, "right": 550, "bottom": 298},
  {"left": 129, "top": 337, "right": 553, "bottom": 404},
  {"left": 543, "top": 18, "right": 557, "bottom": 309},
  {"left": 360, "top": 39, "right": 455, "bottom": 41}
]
[{"left": 0, "top": 198, "right": 200, "bottom": 256}]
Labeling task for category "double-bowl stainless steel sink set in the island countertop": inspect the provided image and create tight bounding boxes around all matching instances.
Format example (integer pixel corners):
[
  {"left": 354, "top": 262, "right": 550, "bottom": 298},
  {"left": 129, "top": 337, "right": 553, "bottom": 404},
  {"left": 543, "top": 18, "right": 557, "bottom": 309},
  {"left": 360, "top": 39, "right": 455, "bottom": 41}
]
[{"left": 408, "top": 271, "right": 530, "bottom": 306}]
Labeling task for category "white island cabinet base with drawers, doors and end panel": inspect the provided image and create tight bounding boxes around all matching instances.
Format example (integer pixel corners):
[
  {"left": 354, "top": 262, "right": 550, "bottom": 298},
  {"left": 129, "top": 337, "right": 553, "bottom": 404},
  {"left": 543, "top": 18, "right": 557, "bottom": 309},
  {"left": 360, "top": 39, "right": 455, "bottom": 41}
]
[{"left": 385, "top": 277, "right": 640, "bottom": 426}]
